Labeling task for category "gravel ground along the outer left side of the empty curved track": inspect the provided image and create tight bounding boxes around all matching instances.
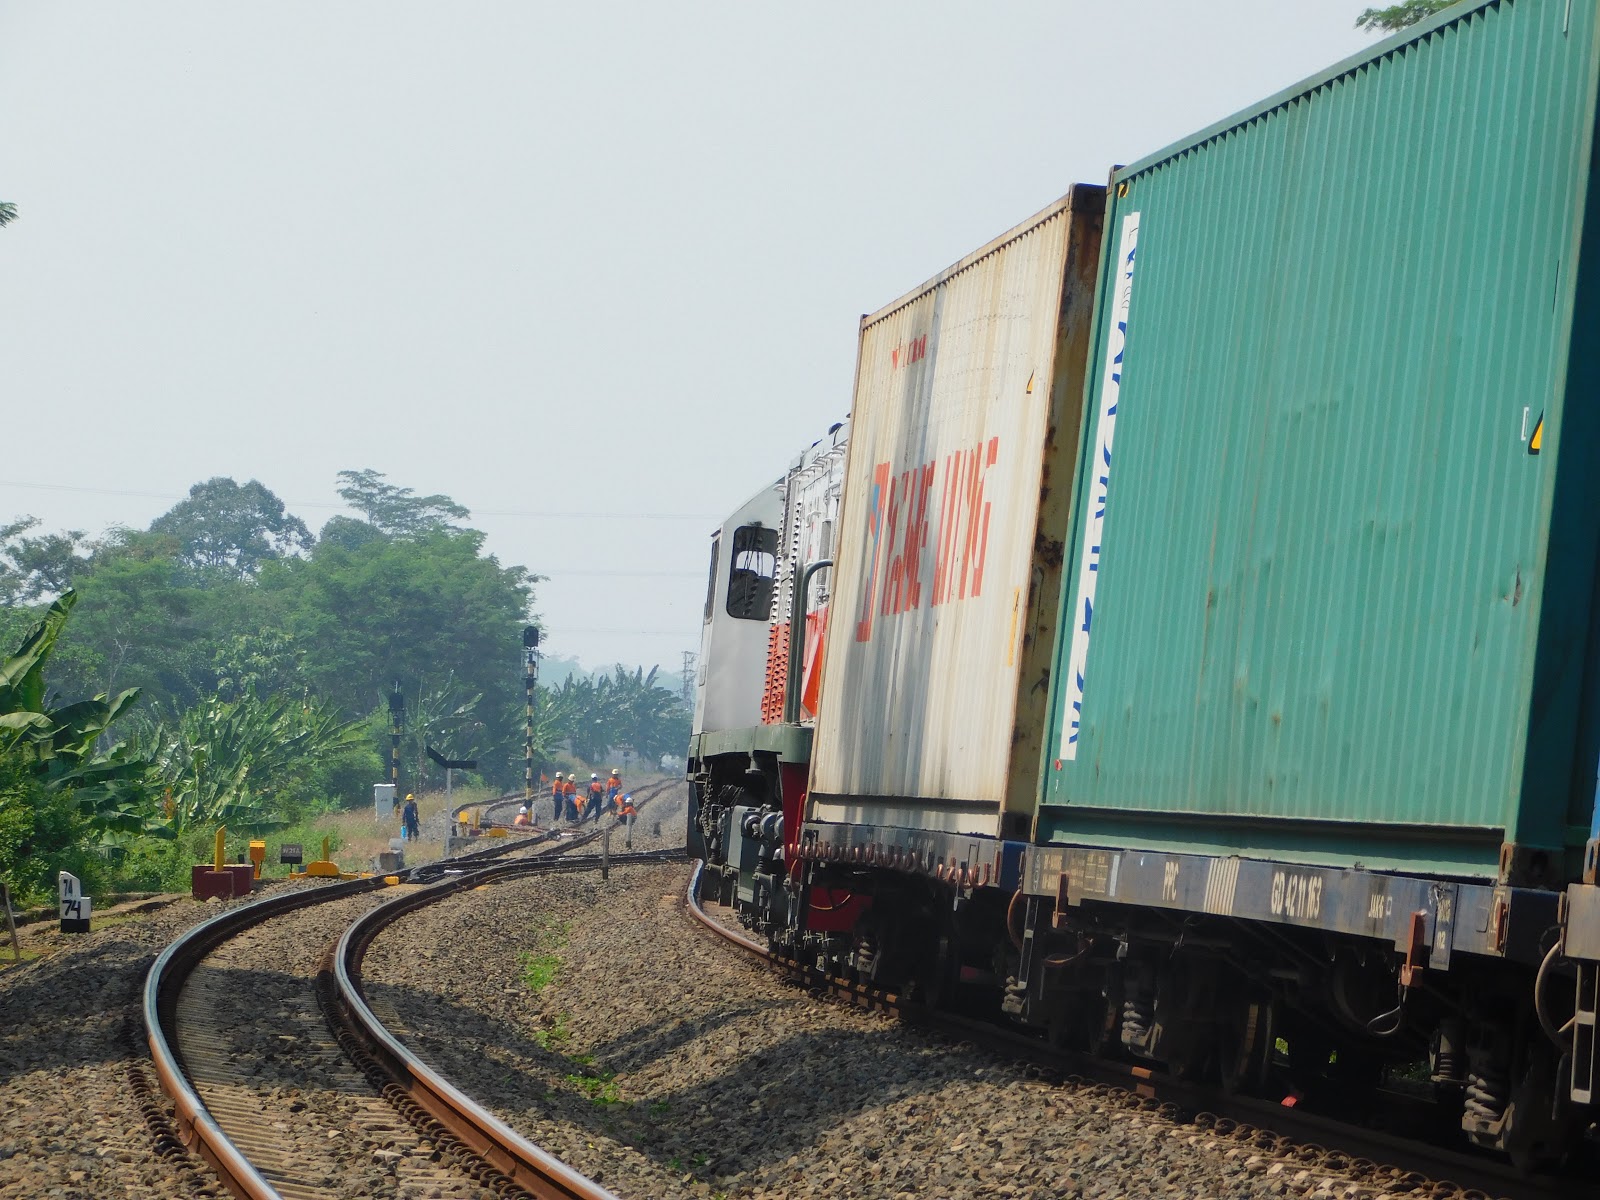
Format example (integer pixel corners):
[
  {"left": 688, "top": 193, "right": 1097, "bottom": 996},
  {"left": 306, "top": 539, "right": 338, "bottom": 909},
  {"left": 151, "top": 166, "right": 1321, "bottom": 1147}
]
[{"left": 0, "top": 899, "right": 267, "bottom": 1200}]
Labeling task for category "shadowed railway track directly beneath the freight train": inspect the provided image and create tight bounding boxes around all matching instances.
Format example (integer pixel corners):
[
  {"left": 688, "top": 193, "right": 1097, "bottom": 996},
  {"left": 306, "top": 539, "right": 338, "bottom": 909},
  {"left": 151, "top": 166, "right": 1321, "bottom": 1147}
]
[{"left": 685, "top": 864, "right": 1595, "bottom": 1200}]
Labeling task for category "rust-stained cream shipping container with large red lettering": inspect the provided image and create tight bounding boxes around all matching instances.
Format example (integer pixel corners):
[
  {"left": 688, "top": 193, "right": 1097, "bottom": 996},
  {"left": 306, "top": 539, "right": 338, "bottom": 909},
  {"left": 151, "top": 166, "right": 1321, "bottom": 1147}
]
[{"left": 811, "top": 186, "right": 1104, "bottom": 835}]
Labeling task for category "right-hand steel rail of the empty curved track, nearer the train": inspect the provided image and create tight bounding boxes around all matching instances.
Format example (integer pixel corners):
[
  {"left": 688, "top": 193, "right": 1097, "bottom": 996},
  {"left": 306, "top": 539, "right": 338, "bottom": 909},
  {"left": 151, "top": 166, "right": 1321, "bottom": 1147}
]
[{"left": 333, "top": 850, "right": 682, "bottom": 1200}]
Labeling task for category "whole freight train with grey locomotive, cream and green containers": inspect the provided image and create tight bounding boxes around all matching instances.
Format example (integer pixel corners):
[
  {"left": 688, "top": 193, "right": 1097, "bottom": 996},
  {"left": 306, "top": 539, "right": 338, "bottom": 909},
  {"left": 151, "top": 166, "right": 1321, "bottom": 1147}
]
[{"left": 688, "top": 0, "right": 1600, "bottom": 1163}]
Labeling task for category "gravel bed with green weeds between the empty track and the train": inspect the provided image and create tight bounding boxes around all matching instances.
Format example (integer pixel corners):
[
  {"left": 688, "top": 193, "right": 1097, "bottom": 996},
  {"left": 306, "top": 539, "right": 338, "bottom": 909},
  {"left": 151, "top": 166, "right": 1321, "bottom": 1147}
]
[{"left": 365, "top": 864, "right": 1363, "bottom": 1200}]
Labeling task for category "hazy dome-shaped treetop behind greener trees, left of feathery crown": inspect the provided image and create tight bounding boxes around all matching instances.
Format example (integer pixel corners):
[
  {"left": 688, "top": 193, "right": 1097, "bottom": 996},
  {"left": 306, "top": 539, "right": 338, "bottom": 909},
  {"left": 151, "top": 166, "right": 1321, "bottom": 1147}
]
[{"left": 150, "top": 475, "right": 312, "bottom": 578}]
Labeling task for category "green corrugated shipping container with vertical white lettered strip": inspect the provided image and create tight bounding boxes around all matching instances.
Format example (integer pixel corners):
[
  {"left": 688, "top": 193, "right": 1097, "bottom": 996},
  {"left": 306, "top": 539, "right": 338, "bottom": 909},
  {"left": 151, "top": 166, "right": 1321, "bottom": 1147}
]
[{"left": 1037, "top": 0, "right": 1600, "bottom": 875}]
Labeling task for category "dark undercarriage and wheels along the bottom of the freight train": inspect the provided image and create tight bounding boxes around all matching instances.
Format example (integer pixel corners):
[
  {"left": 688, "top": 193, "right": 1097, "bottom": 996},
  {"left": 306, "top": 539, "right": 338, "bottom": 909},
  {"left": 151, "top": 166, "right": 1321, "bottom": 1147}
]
[{"left": 691, "top": 793, "right": 1600, "bottom": 1166}]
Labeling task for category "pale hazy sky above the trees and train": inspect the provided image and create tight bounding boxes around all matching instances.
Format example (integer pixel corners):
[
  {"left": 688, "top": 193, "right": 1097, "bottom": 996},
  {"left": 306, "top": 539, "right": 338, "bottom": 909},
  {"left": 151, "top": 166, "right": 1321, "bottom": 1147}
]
[{"left": 0, "top": 0, "right": 1371, "bottom": 669}]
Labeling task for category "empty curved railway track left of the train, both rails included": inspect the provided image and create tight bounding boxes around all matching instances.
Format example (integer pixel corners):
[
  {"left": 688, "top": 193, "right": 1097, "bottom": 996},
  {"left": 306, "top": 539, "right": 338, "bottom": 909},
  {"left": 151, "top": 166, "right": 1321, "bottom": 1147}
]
[{"left": 144, "top": 781, "right": 682, "bottom": 1200}]
